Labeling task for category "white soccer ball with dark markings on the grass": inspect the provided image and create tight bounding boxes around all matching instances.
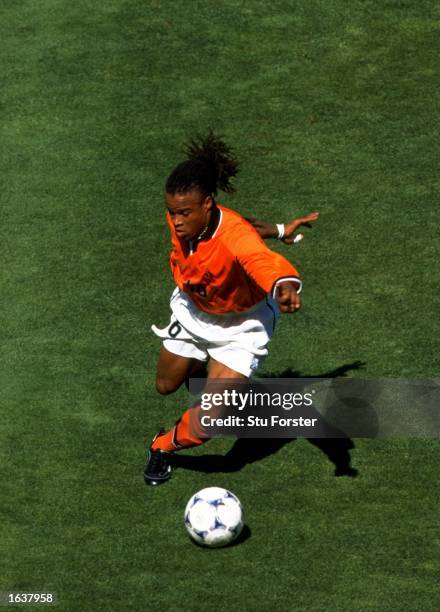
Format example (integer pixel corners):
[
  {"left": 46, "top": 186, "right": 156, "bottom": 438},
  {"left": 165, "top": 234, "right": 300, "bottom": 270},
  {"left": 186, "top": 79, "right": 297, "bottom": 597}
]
[{"left": 185, "top": 487, "right": 243, "bottom": 548}]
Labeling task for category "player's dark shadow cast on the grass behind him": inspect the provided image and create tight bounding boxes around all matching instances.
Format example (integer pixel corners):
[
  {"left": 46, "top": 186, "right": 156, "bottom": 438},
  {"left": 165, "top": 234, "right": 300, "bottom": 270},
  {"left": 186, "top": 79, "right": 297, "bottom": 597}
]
[{"left": 168, "top": 361, "right": 365, "bottom": 478}]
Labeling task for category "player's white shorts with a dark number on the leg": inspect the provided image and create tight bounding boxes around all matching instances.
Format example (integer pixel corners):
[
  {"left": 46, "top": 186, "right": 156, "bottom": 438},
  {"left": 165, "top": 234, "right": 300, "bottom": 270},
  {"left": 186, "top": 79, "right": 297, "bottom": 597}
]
[{"left": 151, "top": 287, "right": 279, "bottom": 377}]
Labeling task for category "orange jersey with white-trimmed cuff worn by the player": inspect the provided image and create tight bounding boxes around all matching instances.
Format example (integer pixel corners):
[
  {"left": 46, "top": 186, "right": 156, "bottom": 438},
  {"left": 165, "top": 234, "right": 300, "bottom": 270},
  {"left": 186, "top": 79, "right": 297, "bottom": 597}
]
[{"left": 167, "top": 205, "right": 300, "bottom": 314}]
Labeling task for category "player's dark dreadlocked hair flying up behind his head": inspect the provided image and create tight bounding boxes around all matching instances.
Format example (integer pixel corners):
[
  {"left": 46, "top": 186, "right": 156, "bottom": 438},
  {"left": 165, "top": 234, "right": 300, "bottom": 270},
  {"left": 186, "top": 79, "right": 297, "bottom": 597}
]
[{"left": 165, "top": 130, "right": 239, "bottom": 195}]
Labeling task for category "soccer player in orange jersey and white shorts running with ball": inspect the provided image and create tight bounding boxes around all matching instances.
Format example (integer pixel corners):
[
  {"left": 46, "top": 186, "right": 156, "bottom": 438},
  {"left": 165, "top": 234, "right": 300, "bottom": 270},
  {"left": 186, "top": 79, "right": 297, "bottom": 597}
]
[{"left": 144, "top": 132, "right": 318, "bottom": 485}]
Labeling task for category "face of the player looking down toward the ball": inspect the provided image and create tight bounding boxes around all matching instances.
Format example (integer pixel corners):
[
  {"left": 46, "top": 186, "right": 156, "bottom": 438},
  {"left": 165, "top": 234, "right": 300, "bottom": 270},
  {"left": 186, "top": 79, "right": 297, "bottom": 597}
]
[{"left": 165, "top": 191, "right": 212, "bottom": 240}]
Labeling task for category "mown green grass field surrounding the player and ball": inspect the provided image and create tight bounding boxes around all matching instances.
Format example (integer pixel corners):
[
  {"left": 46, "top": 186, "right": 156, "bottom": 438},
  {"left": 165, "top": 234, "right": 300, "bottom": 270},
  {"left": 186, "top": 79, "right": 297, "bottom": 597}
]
[{"left": 0, "top": 0, "right": 440, "bottom": 612}]
